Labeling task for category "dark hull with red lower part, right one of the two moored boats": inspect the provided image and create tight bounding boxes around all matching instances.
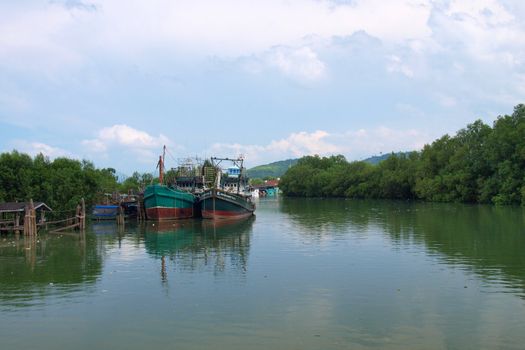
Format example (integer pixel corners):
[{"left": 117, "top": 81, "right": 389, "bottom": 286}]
[{"left": 200, "top": 189, "right": 255, "bottom": 220}]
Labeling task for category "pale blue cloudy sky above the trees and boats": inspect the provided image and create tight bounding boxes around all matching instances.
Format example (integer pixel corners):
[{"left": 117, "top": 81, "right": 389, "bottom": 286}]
[{"left": 0, "top": 0, "right": 525, "bottom": 174}]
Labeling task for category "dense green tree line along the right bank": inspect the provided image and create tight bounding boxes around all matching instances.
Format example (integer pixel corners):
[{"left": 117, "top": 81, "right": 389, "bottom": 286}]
[{"left": 279, "top": 104, "right": 525, "bottom": 205}]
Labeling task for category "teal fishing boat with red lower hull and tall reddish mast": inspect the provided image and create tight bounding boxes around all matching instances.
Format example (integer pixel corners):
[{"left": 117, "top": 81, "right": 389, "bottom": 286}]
[{"left": 144, "top": 146, "right": 196, "bottom": 221}]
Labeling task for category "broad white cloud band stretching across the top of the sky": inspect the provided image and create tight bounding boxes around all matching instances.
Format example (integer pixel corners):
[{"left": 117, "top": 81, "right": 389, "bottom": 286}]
[{"left": 4, "top": 0, "right": 525, "bottom": 93}]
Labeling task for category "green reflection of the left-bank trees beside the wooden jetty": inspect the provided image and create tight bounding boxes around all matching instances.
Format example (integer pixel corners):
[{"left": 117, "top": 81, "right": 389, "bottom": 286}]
[{"left": 0, "top": 234, "right": 102, "bottom": 310}]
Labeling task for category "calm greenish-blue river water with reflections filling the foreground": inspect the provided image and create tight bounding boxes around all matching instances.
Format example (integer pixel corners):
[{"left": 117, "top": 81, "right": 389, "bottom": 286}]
[{"left": 0, "top": 200, "right": 525, "bottom": 350}]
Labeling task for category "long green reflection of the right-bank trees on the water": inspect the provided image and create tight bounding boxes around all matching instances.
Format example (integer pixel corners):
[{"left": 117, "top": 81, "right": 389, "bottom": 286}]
[{"left": 281, "top": 199, "right": 525, "bottom": 296}]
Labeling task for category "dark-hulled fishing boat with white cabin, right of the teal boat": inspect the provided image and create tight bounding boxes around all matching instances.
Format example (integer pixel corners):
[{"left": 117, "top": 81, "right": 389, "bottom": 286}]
[{"left": 200, "top": 157, "right": 255, "bottom": 219}]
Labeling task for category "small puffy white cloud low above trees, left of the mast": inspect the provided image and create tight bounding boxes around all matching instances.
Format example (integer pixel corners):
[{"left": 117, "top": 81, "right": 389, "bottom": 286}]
[{"left": 82, "top": 124, "right": 173, "bottom": 162}]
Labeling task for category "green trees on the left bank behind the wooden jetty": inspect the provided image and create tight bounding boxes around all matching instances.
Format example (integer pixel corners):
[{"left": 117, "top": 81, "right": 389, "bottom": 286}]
[{"left": 0, "top": 151, "right": 118, "bottom": 211}]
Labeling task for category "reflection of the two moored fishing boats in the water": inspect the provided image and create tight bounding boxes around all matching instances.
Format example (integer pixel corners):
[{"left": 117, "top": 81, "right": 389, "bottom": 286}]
[{"left": 144, "top": 218, "right": 255, "bottom": 282}]
